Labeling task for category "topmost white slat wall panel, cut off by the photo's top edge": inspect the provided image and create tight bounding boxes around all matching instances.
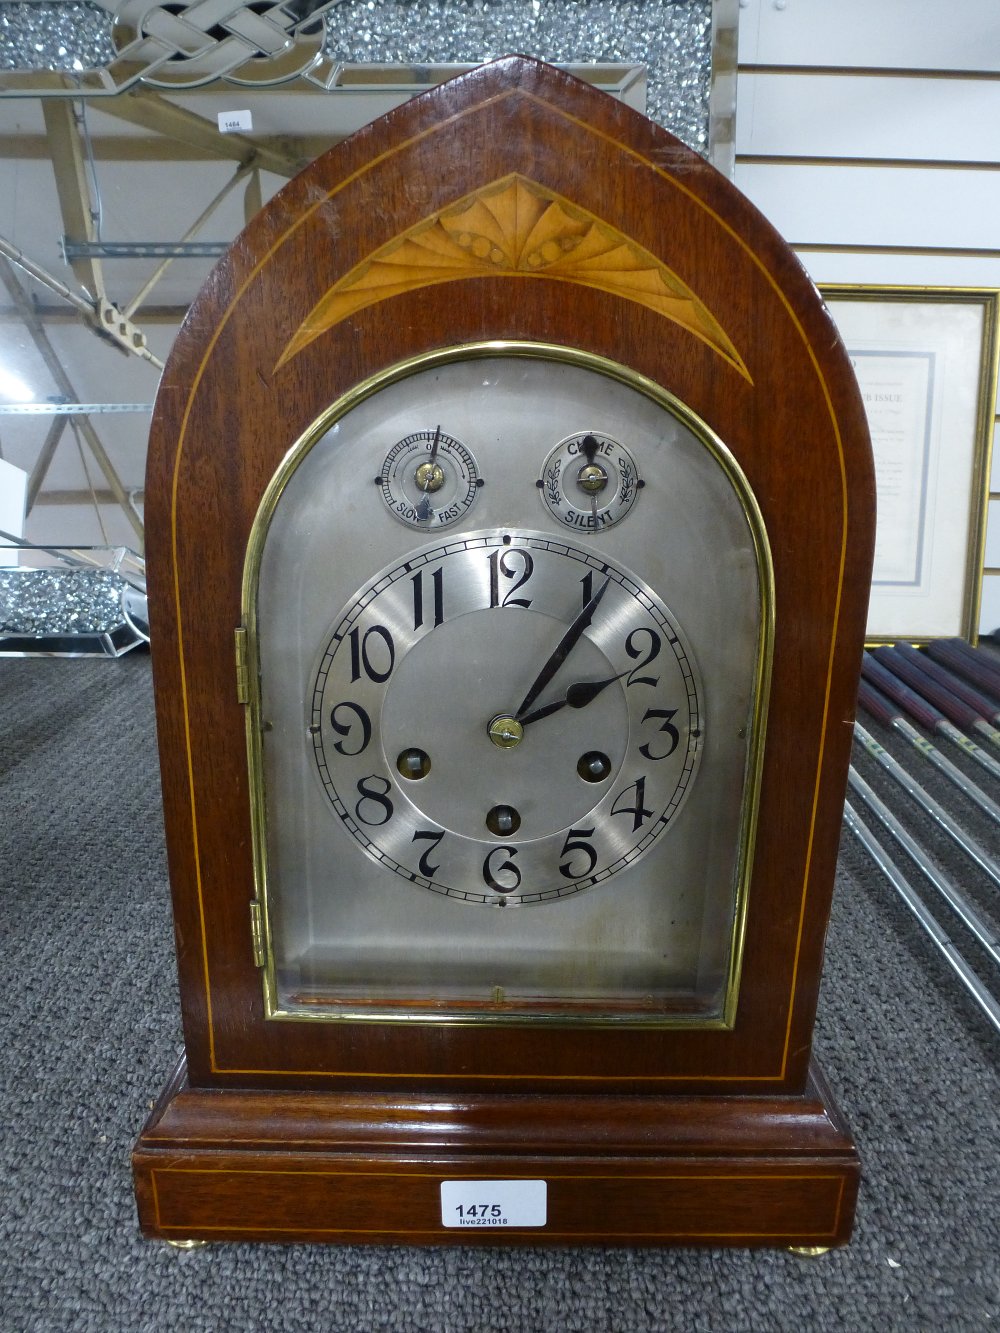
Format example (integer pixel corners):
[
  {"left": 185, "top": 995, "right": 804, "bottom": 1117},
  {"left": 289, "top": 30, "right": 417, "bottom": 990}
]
[{"left": 740, "top": 0, "right": 1000, "bottom": 69}]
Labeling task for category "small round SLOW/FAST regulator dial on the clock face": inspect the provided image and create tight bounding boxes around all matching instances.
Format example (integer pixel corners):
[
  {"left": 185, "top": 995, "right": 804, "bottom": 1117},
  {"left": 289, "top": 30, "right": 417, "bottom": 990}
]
[{"left": 377, "top": 425, "right": 483, "bottom": 529}]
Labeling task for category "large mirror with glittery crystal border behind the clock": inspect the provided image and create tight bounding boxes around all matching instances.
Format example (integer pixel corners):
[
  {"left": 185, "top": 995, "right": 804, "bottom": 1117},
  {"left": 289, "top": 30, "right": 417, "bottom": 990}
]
[{"left": 0, "top": 0, "right": 739, "bottom": 656}]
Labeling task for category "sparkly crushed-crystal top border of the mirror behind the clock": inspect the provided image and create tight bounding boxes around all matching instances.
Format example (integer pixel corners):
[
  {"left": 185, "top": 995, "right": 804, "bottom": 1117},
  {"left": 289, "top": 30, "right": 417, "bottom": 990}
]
[{"left": 0, "top": 0, "right": 739, "bottom": 177}]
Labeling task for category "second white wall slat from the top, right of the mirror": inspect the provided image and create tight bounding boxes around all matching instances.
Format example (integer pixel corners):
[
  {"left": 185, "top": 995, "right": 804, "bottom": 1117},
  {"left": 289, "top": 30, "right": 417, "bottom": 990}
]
[{"left": 736, "top": 72, "right": 1000, "bottom": 161}]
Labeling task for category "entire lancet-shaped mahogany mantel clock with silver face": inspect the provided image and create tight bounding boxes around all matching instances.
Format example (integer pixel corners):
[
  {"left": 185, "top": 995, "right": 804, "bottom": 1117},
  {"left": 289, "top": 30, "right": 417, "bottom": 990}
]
[{"left": 135, "top": 57, "right": 873, "bottom": 1246}]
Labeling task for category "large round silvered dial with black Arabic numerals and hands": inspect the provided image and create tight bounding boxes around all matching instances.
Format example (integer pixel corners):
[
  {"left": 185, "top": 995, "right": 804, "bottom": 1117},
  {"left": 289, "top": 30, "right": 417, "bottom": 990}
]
[{"left": 309, "top": 531, "right": 704, "bottom": 906}]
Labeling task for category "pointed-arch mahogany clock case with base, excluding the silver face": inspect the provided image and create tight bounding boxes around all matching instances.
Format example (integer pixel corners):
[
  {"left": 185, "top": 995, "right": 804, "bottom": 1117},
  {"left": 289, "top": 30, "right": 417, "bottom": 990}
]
[{"left": 135, "top": 57, "right": 873, "bottom": 1244}]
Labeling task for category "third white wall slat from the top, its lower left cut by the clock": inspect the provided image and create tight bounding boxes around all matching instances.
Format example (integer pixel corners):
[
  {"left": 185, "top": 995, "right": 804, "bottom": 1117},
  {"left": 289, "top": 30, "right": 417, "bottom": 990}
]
[{"left": 736, "top": 163, "right": 1000, "bottom": 251}]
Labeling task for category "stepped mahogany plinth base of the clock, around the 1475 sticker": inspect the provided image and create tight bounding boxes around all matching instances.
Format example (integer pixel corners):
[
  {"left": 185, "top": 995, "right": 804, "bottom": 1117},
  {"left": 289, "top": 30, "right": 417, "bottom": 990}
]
[{"left": 132, "top": 1062, "right": 859, "bottom": 1250}]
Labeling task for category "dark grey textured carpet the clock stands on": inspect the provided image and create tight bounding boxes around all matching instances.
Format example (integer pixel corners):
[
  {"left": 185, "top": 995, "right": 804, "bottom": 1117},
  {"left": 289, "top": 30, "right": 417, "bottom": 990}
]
[{"left": 0, "top": 655, "right": 1000, "bottom": 1333}]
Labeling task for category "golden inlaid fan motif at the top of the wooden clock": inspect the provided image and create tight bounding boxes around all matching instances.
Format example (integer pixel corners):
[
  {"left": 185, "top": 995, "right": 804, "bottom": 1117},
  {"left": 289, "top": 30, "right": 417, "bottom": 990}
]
[{"left": 277, "top": 172, "right": 749, "bottom": 379}]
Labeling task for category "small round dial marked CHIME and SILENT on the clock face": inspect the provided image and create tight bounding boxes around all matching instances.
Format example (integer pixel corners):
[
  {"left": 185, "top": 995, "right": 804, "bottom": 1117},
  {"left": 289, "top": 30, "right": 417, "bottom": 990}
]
[{"left": 536, "top": 431, "right": 644, "bottom": 532}]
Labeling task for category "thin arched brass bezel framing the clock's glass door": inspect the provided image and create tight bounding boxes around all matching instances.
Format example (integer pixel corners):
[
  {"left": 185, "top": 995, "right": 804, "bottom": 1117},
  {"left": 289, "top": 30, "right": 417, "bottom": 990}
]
[{"left": 239, "top": 340, "right": 775, "bottom": 1029}]
